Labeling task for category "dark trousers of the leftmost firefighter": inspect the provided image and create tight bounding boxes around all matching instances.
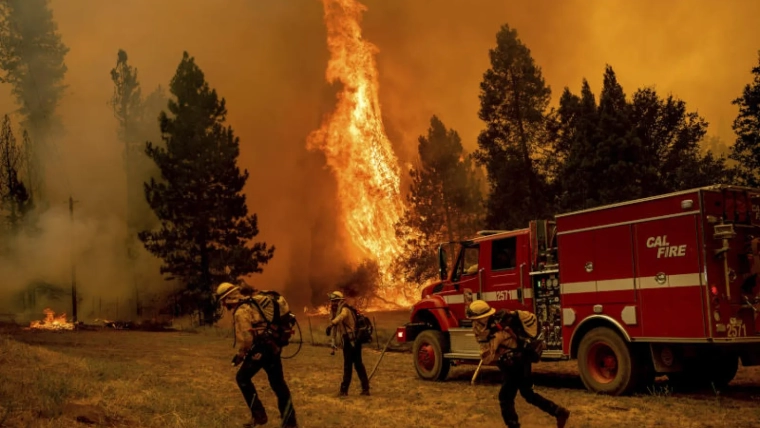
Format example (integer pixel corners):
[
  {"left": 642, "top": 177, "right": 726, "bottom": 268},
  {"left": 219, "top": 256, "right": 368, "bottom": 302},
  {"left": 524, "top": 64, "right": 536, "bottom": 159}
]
[{"left": 235, "top": 345, "right": 296, "bottom": 427}]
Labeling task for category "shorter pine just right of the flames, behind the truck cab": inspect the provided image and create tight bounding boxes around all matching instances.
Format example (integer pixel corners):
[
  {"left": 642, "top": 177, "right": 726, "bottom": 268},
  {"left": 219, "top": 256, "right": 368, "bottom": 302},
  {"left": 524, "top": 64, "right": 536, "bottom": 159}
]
[{"left": 396, "top": 116, "right": 482, "bottom": 284}]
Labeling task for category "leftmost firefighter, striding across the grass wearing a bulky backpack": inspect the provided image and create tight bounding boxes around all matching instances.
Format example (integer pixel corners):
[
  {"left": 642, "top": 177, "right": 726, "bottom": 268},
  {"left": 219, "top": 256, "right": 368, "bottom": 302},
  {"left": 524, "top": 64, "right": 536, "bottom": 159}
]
[{"left": 216, "top": 282, "right": 298, "bottom": 427}]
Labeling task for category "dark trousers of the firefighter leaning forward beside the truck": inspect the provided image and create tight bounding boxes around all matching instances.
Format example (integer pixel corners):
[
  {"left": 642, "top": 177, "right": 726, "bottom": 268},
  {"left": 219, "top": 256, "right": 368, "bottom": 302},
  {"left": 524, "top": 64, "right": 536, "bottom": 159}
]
[{"left": 499, "top": 361, "right": 561, "bottom": 428}]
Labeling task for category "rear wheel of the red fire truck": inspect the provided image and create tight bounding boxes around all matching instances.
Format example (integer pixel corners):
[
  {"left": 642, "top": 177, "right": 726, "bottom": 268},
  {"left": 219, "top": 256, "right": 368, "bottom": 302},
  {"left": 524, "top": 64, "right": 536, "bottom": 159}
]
[{"left": 578, "top": 327, "right": 636, "bottom": 395}]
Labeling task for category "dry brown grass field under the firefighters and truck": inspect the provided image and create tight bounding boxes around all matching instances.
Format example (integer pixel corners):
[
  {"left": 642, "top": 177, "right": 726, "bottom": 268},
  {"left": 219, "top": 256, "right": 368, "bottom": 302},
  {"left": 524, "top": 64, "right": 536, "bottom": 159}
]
[{"left": 0, "top": 313, "right": 760, "bottom": 428}]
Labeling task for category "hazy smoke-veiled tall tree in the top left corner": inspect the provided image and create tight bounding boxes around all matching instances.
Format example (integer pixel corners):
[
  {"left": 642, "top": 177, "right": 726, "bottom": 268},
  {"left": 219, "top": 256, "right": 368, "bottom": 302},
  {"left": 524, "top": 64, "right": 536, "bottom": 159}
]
[{"left": 0, "top": 0, "right": 69, "bottom": 200}]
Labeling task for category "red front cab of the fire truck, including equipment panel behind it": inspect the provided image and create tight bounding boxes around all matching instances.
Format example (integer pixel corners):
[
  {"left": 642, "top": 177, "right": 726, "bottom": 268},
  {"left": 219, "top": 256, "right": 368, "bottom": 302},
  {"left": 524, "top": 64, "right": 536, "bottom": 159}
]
[{"left": 396, "top": 220, "right": 562, "bottom": 380}]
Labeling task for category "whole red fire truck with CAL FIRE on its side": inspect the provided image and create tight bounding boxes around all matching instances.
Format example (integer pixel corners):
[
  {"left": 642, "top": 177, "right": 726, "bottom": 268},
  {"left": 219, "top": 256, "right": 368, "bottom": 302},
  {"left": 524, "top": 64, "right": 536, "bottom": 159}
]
[{"left": 396, "top": 185, "right": 760, "bottom": 395}]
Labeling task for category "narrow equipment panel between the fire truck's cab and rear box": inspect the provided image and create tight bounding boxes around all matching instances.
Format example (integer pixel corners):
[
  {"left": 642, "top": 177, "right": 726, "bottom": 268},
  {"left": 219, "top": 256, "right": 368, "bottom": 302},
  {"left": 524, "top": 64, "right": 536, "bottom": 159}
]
[{"left": 533, "top": 273, "right": 562, "bottom": 351}]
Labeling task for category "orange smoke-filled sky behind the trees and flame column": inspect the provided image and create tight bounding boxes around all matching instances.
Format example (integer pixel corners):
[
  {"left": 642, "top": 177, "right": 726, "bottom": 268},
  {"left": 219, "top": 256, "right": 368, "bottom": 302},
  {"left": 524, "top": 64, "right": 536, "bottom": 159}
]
[{"left": 0, "top": 0, "right": 760, "bottom": 300}]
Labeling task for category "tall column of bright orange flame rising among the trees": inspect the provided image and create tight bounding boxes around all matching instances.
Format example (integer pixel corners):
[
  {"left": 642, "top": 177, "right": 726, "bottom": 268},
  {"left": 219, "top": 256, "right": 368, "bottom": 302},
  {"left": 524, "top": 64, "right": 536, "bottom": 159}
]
[{"left": 307, "top": 0, "right": 403, "bottom": 280}]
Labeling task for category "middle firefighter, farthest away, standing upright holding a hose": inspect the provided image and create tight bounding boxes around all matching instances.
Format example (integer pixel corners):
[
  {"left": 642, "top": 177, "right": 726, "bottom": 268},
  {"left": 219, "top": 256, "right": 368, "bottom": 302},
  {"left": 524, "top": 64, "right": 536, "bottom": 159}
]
[{"left": 325, "top": 291, "right": 369, "bottom": 397}]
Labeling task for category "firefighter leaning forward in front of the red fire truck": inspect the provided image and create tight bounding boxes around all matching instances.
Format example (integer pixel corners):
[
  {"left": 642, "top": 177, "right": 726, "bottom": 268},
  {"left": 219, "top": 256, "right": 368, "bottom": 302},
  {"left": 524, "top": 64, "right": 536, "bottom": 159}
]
[{"left": 467, "top": 300, "right": 570, "bottom": 428}]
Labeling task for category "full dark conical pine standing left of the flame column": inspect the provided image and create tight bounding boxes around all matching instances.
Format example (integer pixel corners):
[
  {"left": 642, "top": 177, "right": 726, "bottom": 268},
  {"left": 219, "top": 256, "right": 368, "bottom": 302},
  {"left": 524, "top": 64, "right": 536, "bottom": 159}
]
[{"left": 139, "top": 52, "right": 274, "bottom": 322}]
